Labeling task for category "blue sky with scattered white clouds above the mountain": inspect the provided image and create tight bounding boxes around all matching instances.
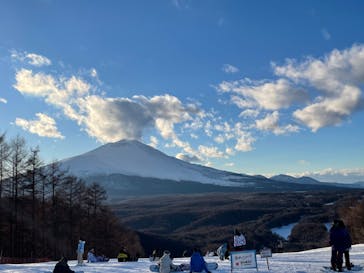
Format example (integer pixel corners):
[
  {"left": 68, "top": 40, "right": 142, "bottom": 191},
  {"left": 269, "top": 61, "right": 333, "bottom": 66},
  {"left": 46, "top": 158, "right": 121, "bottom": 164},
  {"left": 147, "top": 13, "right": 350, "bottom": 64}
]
[{"left": 0, "top": 0, "right": 364, "bottom": 182}]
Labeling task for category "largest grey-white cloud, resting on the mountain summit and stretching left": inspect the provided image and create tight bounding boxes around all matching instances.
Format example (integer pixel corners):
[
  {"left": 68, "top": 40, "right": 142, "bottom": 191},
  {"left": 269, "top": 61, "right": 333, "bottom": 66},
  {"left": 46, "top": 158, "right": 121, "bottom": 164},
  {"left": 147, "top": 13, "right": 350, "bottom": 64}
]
[{"left": 14, "top": 69, "right": 200, "bottom": 144}]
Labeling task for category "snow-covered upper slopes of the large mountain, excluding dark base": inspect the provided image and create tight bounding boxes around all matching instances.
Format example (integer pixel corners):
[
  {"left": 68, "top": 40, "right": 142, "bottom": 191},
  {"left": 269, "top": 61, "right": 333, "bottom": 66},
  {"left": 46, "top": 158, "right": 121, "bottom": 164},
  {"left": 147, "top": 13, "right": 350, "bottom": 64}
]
[{"left": 61, "top": 140, "right": 255, "bottom": 186}]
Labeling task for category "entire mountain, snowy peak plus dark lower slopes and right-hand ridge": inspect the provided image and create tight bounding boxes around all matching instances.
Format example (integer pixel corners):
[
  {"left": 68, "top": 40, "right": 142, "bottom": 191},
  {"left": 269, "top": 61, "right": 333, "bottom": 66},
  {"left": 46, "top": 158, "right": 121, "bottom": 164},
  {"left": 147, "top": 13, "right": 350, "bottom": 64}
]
[{"left": 60, "top": 140, "right": 360, "bottom": 198}]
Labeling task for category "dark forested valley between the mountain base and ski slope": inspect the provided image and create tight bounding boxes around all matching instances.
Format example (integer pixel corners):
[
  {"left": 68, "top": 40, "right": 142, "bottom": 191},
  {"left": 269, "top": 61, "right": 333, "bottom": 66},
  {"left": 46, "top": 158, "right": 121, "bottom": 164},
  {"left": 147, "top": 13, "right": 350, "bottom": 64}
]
[{"left": 113, "top": 189, "right": 364, "bottom": 255}]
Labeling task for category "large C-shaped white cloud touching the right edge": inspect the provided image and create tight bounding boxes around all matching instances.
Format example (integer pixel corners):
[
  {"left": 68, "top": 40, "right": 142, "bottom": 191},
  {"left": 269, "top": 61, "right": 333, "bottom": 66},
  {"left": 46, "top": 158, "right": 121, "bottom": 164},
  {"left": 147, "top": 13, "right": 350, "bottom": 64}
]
[{"left": 273, "top": 45, "right": 364, "bottom": 132}]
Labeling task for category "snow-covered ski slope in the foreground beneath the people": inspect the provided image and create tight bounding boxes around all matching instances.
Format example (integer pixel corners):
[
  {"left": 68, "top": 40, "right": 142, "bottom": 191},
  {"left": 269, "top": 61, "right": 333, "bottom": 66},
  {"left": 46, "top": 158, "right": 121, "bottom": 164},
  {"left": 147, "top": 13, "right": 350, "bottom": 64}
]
[{"left": 0, "top": 244, "right": 364, "bottom": 273}]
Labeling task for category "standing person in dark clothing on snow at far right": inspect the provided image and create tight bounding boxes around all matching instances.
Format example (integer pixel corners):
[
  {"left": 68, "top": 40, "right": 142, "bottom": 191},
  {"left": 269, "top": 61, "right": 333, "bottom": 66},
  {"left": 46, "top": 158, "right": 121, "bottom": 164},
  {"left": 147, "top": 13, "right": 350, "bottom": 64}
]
[{"left": 330, "top": 220, "right": 351, "bottom": 272}]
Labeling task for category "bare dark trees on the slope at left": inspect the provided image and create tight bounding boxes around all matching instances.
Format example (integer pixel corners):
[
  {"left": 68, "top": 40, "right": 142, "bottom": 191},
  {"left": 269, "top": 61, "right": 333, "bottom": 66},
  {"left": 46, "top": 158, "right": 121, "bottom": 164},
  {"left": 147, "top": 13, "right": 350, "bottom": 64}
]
[{"left": 0, "top": 134, "right": 143, "bottom": 259}]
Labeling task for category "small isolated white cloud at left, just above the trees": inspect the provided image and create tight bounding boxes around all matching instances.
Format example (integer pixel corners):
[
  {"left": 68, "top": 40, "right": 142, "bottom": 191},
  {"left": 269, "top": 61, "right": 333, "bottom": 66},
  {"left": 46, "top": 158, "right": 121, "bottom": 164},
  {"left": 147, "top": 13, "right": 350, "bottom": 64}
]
[{"left": 15, "top": 113, "right": 64, "bottom": 139}]
